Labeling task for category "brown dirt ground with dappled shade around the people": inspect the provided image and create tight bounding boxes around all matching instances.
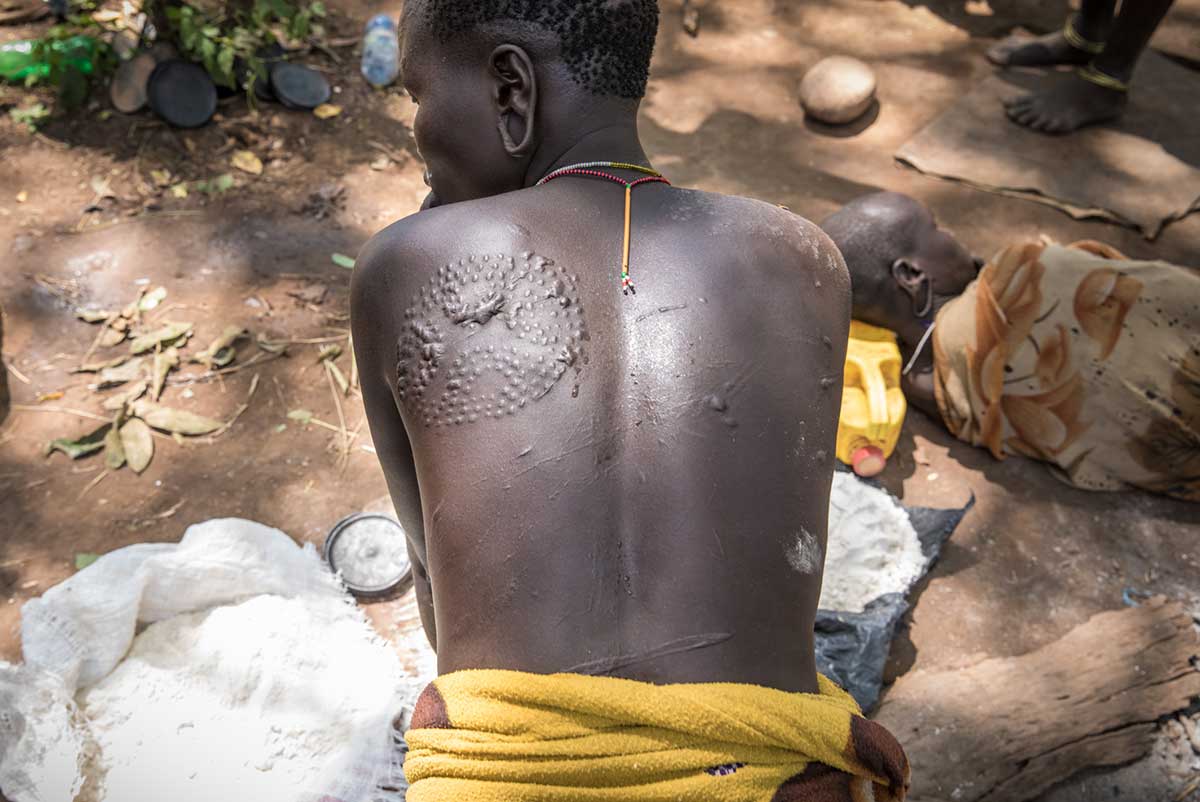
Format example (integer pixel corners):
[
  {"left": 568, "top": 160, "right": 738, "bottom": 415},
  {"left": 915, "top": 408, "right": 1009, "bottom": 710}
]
[{"left": 0, "top": 0, "right": 1200, "bottom": 802}]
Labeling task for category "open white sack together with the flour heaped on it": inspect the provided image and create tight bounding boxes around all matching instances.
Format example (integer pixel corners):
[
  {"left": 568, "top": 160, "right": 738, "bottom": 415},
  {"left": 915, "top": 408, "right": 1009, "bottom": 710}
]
[{"left": 0, "top": 519, "right": 419, "bottom": 802}]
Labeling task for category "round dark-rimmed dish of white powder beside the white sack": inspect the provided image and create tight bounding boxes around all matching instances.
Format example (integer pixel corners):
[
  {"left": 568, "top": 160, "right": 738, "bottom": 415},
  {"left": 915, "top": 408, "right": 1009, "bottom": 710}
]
[{"left": 325, "top": 513, "right": 413, "bottom": 598}]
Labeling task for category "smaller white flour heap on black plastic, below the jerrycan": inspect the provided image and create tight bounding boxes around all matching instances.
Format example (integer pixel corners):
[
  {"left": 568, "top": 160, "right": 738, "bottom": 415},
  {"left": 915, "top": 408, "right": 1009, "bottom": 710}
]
[{"left": 820, "top": 472, "right": 926, "bottom": 612}]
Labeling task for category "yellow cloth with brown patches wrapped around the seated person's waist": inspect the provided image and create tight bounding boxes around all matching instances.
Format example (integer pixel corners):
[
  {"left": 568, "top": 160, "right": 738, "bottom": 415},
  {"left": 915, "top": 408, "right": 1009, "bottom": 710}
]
[{"left": 404, "top": 670, "right": 908, "bottom": 802}]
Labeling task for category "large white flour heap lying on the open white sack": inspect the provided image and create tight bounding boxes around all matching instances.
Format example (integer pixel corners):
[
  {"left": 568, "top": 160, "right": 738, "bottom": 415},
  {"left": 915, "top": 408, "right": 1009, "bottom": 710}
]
[{"left": 79, "top": 595, "right": 406, "bottom": 802}]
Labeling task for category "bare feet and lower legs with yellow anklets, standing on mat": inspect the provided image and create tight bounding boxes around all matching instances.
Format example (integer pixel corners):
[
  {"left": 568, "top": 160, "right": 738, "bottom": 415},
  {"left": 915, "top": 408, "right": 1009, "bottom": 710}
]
[{"left": 988, "top": 0, "right": 1175, "bottom": 133}]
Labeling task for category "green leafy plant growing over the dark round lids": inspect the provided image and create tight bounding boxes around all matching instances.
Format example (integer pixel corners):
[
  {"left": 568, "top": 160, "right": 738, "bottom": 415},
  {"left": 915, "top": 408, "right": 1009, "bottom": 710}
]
[{"left": 149, "top": 0, "right": 325, "bottom": 90}]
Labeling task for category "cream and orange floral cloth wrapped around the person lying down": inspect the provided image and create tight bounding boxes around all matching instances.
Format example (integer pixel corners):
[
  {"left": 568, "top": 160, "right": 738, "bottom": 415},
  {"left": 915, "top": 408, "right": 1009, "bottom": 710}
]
[{"left": 934, "top": 241, "right": 1200, "bottom": 501}]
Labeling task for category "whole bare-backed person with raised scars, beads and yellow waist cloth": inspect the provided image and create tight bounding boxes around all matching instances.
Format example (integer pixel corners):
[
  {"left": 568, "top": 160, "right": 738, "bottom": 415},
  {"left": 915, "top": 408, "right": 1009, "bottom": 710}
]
[{"left": 352, "top": 0, "right": 904, "bottom": 801}]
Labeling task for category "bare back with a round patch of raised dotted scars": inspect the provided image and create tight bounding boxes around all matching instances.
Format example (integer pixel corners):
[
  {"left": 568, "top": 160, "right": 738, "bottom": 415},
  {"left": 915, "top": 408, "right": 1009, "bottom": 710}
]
[{"left": 353, "top": 178, "right": 850, "bottom": 692}]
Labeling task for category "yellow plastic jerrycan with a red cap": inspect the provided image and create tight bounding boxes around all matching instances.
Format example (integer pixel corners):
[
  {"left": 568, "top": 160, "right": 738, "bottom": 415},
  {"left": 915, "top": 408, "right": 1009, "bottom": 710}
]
[{"left": 838, "top": 321, "right": 908, "bottom": 477}]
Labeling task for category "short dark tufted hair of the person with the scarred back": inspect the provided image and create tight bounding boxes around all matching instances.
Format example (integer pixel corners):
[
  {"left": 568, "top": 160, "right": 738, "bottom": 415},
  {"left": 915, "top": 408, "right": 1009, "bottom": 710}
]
[{"left": 412, "top": 0, "right": 659, "bottom": 100}]
